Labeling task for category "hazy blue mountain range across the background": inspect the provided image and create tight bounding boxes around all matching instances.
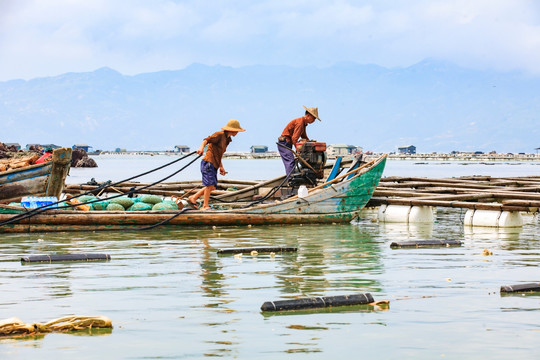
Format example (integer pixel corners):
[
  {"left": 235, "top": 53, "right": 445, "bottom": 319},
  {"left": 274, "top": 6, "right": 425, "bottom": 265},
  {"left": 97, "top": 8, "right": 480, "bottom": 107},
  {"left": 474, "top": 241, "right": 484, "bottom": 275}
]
[{"left": 0, "top": 60, "right": 540, "bottom": 152}]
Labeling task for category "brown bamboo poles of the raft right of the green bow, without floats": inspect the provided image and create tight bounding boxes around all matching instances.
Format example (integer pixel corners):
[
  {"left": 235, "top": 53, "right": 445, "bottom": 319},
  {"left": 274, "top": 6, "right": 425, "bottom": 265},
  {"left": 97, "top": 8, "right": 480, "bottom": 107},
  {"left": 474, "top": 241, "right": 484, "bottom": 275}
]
[{"left": 366, "top": 176, "right": 540, "bottom": 213}]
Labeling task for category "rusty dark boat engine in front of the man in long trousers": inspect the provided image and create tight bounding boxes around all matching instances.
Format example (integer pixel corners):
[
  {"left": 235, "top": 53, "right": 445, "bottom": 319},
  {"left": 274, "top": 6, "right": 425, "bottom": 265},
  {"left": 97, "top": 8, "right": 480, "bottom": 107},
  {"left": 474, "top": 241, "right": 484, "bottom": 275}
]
[{"left": 289, "top": 141, "right": 326, "bottom": 187}]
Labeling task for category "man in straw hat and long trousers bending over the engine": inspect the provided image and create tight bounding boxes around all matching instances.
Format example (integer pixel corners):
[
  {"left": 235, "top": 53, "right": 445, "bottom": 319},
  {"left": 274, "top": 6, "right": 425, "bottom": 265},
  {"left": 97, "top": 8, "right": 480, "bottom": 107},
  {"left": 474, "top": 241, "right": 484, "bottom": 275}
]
[{"left": 278, "top": 106, "right": 321, "bottom": 175}]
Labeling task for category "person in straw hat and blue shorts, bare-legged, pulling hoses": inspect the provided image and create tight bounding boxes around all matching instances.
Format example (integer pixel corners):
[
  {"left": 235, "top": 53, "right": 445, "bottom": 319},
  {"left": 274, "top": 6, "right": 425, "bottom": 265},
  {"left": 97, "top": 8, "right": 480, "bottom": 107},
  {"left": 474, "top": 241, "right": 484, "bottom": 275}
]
[{"left": 188, "top": 119, "right": 246, "bottom": 210}]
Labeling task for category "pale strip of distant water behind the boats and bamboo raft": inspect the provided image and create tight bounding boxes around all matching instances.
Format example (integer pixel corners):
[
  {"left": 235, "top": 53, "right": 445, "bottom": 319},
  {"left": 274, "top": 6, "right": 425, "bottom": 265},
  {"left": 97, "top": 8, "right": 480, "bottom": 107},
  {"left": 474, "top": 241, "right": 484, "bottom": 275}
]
[{"left": 67, "top": 155, "right": 540, "bottom": 184}]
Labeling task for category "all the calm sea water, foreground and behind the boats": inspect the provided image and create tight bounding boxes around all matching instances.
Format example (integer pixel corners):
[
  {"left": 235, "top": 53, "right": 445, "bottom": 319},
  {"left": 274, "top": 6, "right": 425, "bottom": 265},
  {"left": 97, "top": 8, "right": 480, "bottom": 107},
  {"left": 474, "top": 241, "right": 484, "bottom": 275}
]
[{"left": 0, "top": 156, "right": 540, "bottom": 359}]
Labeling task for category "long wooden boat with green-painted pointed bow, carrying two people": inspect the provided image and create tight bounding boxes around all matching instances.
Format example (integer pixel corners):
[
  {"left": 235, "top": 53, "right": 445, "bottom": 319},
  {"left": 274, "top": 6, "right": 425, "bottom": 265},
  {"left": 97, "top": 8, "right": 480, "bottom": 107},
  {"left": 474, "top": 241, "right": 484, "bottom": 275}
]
[{"left": 0, "top": 155, "right": 387, "bottom": 233}]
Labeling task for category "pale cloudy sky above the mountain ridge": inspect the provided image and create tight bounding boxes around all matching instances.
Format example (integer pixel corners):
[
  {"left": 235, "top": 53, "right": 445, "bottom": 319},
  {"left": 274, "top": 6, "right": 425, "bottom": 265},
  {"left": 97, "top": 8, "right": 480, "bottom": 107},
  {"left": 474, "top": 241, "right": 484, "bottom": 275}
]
[{"left": 0, "top": 0, "right": 540, "bottom": 81}]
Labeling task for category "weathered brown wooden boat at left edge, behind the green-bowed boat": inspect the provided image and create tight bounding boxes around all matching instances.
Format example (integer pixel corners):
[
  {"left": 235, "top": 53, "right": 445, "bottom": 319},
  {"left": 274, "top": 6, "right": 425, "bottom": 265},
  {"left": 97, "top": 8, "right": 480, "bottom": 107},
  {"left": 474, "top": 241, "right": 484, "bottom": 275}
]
[{"left": 0, "top": 148, "right": 71, "bottom": 203}]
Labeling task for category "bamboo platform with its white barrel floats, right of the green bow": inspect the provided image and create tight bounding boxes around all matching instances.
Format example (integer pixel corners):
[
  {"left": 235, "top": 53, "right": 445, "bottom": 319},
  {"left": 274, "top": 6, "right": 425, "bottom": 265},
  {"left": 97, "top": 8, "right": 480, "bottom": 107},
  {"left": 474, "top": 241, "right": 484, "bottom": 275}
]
[{"left": 366, "top": 176, "right": 540, "bottom": 227}]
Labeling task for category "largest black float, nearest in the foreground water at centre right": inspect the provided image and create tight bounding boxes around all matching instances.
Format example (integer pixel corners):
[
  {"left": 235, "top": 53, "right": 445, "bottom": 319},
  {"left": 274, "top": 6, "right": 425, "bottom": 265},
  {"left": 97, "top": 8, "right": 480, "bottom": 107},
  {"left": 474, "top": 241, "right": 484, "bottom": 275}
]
[{"left": 261, "top": 293, "right": 375, "bottom": 311}]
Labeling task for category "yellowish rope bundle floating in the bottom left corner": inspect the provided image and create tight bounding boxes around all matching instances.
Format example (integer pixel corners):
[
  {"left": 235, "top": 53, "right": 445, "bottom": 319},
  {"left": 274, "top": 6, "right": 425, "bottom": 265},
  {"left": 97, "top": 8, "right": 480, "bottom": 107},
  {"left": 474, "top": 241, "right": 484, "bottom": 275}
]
[{"left": 0, "top": 315, "right": 112, "bottom": 336}]
